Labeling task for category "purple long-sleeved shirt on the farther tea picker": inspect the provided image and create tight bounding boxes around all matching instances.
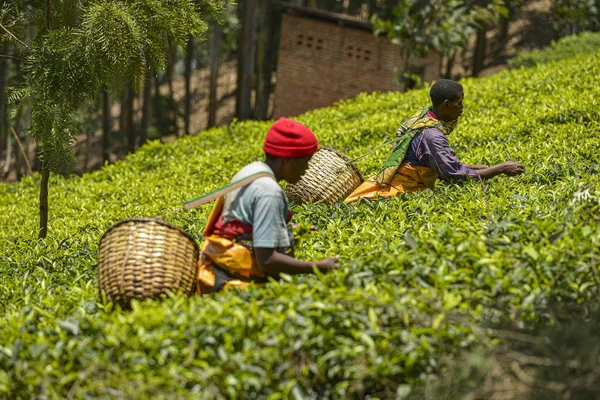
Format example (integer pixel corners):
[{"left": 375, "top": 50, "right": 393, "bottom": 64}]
[{"left": 404, "top": 128, "right": 477, "bottom": 181}]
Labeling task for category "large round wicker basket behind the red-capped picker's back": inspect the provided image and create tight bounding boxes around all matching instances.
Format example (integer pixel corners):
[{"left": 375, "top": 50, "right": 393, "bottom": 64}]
[{"left": 98, "top": 218, "right": 199, "bottom": 307}]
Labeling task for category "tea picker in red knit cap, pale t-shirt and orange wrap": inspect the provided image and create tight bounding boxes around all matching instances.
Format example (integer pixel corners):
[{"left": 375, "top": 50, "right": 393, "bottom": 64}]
[{"left": 184, "top": 118, "right": 339, "bottom": 294}]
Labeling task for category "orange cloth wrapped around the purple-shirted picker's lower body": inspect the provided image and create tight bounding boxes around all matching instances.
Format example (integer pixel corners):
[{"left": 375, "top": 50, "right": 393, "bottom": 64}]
[{"left": 344, "top": 163, "right": 438, "bottom": 204}]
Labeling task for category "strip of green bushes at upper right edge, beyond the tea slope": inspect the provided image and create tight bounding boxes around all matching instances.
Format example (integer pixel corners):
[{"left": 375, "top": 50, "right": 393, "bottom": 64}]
[{"left": 509, "top": 32, "right": 600, "bottom": 68}]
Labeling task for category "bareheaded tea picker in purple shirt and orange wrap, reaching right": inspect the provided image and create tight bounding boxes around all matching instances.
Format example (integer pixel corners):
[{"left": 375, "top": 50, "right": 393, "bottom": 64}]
[{"left": 344, "top": 79, "right": 525, "bottom": 204}]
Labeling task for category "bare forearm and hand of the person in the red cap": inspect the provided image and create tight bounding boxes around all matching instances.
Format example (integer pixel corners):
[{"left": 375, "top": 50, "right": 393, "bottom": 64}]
[{"left": 254, "top": 247, "right": 340, "bottom": 277}]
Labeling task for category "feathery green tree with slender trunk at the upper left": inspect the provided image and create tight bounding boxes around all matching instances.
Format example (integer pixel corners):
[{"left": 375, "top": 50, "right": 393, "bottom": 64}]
[{"left": 1, "top": 0, "right": 222, "bottom": 238}]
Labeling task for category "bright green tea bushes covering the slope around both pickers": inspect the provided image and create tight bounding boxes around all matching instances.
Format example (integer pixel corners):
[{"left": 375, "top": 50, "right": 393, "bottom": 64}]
[{"left": 0, "top": 34, "right": 600, "bottom": 399}]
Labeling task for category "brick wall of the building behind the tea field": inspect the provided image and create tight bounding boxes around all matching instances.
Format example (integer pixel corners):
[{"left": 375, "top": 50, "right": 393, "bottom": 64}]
[{"left": 273, "top": 14, "right": 440, "bottom": 118}]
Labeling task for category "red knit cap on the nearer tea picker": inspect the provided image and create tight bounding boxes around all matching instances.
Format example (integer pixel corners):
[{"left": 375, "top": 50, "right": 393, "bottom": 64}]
[{"left": 263, "top": 118, "right": 319, "bottom": 158}]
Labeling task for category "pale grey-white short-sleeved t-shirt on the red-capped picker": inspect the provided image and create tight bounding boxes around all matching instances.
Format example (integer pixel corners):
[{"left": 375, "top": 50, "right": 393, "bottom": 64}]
[{"left": 222, "top": 161, "right": 291, "bottom": 248}]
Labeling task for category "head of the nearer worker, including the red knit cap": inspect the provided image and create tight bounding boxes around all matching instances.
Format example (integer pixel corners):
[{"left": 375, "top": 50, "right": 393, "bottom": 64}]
[{"left": 263, "top": 118, "right": 319, "bottom": 183}]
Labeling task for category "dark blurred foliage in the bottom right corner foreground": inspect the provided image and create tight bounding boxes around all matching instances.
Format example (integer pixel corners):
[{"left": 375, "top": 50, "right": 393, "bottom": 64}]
[{"left": 411, "top": 301, "right": 600, "bottom": 400}]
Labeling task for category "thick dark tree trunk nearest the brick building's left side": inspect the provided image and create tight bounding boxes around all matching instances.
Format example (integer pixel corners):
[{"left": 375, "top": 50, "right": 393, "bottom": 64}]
[{"left": 236, "top": 0, "right": 257, "bottom": 120}]
